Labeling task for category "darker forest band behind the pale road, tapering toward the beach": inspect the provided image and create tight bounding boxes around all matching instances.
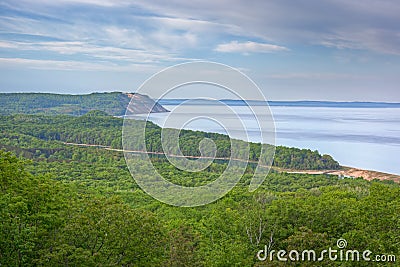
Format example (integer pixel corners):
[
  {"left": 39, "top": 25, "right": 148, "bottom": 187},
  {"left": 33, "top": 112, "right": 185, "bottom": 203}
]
[{"left": 0, "top": 111, "right": 340, "bottom": 169}]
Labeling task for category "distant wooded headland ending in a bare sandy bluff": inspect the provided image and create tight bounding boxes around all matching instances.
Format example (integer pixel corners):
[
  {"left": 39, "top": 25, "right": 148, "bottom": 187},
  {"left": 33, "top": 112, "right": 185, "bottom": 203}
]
[{"left": 0, "top": 92, "right": 168, "bottom": 116}]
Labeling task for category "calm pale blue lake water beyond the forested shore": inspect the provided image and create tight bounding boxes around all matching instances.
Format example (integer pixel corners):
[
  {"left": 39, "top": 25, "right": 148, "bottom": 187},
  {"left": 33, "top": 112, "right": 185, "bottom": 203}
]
[{"left": 130, "top": 105, "right": 400, "bottom": 174}]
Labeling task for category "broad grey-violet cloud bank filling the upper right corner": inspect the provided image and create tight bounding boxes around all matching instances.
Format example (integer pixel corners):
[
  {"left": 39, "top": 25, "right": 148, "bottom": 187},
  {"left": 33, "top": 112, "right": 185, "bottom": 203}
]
[{"left": 136, "top": 0, "right": 400, "bottom": 55}]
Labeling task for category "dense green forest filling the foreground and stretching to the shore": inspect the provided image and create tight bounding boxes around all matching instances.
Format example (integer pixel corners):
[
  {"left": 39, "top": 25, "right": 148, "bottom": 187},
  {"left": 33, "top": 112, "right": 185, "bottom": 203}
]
[{"left": 0, "top": 111, "right": 400, "bottom": 266}]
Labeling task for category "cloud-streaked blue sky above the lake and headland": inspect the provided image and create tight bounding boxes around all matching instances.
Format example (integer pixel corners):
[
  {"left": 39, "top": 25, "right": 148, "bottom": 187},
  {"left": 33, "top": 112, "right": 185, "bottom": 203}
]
[{"left": 0, "top": 0, "right": 400, "bottom": 102}]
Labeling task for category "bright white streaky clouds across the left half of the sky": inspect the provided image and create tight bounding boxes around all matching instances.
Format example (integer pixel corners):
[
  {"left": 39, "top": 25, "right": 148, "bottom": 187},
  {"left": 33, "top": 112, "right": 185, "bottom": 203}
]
[{"left": 0, "top": 3, "right": 208, "bottom": 64}]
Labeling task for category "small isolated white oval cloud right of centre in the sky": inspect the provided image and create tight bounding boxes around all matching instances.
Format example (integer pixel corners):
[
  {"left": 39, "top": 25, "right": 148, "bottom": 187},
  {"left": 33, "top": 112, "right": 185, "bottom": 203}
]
[{"left": 214, "top": 41, "right": 289, "bottom": 54}]
